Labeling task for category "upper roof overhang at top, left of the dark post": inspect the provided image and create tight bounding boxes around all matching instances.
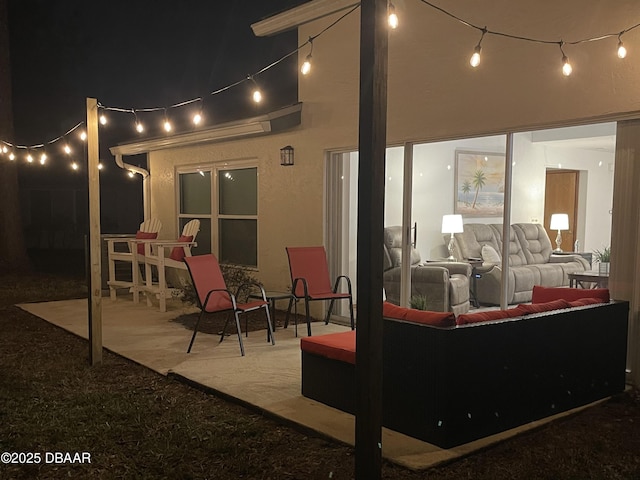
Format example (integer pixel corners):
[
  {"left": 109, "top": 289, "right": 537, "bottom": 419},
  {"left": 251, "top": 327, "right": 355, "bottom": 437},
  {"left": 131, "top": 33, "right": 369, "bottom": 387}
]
[{"left": 251, "top": 0, "right": 360, "bottom": 37}]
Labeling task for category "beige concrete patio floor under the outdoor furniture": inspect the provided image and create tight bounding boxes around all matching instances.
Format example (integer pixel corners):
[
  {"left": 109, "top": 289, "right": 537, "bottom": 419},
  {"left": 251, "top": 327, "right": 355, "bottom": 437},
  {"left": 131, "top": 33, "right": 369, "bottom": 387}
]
[{"left": 19, "top": 295, "right": 604, "bottom": 470}]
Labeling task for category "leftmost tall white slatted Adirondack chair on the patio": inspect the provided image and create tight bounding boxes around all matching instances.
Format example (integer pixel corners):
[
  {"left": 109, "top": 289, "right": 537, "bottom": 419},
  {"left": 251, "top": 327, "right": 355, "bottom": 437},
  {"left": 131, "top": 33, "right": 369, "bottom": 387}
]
[{"left": 106, "top": 218, "right": 162, "bottom": 303}]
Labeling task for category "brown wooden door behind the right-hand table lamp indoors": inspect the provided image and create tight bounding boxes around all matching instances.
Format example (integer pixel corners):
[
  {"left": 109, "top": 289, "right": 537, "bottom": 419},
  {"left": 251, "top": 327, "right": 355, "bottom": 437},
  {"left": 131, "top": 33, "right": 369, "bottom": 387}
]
[{"left": 544, "top": 169, "right": 580, "bottom": 252}]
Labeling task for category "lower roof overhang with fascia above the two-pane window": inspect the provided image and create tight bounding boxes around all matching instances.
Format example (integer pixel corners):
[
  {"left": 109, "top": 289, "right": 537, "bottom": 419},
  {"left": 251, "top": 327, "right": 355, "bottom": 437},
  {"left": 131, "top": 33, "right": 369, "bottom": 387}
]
[{"left": 109, "top": 103, "right": 302, "bottom": 156}]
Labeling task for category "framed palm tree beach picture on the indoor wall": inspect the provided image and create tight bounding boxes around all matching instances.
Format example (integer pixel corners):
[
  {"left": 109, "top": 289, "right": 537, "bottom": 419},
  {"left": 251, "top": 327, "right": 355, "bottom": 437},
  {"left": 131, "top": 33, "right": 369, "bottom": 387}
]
[{"left": 454, "top": 150, "right": 505, "bottom": 217}]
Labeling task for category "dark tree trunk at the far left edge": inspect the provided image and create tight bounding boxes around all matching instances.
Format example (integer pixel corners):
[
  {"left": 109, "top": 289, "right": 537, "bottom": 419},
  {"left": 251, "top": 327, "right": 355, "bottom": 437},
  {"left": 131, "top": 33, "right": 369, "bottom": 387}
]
[{"left": 0, "top": 0, "right": 29, "bottom": 273}]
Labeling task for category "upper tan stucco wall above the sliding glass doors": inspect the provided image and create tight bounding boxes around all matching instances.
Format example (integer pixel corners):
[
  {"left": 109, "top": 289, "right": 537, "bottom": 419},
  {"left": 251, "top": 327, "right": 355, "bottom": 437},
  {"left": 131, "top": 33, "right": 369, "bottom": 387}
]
[{"left": 299, "top": 0, "right": 640, "bottom": 148}]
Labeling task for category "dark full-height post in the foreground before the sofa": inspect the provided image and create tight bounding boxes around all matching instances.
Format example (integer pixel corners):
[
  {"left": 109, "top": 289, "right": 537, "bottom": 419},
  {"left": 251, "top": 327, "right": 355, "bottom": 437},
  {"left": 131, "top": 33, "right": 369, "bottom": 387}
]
[{"left": 355, "top": 0, "right": 388, "bottom": 480}]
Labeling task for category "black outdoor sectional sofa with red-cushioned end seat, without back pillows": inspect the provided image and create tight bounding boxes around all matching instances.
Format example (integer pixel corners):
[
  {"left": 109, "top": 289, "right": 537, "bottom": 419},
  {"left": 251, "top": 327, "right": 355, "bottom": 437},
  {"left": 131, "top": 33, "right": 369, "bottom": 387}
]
[{"left": 301, "top": 292, "right": 629, "bottom": 448}]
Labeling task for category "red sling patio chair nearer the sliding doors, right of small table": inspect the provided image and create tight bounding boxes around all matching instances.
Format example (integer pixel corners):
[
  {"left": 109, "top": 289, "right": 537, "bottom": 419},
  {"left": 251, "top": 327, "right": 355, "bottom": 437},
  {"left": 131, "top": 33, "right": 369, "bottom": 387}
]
[{"left": 285, "top": 246, "right": 355, "bottom": 336}]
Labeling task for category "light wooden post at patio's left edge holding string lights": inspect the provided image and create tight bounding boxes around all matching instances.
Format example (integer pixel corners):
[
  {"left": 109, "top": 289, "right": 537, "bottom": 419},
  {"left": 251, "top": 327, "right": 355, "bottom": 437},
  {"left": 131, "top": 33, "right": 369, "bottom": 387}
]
[{"left": 87, "top": 98, "right": 102, "bottom": 365}]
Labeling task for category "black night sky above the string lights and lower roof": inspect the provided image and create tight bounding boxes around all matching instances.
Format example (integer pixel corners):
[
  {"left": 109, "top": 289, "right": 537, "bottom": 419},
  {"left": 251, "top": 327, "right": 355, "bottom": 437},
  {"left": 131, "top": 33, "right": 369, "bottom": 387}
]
[{"left": 9, "top": 0, "right": 305, "bottom": 161}]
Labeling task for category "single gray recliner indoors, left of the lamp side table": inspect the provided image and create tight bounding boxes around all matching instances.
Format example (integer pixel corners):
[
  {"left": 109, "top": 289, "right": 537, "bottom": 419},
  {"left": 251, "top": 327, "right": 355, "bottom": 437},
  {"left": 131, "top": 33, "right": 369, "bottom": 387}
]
[{"left": 383, "top": 226, "right": 471, "bottom": 315}]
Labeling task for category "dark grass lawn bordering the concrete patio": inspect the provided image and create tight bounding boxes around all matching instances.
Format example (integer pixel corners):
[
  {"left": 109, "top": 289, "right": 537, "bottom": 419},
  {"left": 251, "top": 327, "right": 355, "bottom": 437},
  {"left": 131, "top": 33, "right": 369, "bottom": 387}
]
[{"left": 0, "top": 249, "right": 640, "bottom": 480}]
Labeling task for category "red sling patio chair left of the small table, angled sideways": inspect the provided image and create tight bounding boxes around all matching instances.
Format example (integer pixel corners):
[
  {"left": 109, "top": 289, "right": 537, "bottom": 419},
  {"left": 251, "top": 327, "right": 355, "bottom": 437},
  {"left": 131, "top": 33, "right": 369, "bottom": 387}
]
[{"left": 184, "top": 253, "right": 276, "bottom": 356}]
